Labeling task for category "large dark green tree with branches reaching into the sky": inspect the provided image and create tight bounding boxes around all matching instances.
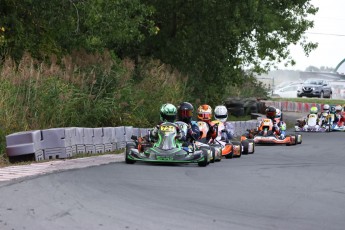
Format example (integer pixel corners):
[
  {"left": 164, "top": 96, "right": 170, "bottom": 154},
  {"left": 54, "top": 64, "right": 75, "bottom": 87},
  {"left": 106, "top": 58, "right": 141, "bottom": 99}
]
[{"left": 138, "top": 0, "right": 317, "bottom": 100}]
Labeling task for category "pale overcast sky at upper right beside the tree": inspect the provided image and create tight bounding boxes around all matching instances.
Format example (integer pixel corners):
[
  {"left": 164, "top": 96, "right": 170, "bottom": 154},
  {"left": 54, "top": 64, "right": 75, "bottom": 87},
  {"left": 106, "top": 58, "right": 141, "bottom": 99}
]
[{"left": 279, "top": 0, "right": 345, "bottom": 70}]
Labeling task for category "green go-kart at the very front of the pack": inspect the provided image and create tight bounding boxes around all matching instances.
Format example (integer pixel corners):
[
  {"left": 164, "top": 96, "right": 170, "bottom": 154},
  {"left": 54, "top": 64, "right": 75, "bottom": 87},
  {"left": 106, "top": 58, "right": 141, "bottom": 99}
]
[{"left": 125, "top": 122, "right": 210, "bottom": 167}]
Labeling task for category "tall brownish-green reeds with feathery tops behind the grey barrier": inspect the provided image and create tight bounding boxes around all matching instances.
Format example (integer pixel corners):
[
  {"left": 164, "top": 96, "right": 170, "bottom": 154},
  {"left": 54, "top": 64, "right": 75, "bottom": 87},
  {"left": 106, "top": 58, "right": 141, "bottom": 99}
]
[{"left": 0, "top": 51, "right": 188, "bottom": 153}]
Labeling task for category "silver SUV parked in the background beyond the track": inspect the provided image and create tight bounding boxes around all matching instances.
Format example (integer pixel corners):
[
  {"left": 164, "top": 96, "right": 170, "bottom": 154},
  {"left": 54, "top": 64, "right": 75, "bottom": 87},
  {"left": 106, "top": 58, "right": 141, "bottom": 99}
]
[{"left": 297, "top": 79, "right": 332, "bottom": 98}]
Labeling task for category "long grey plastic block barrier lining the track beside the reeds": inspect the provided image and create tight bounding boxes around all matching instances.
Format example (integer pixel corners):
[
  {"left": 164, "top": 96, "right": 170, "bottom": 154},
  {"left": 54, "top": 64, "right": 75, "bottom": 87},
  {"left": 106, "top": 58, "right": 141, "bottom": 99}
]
[{"left": 6, "top": 120, "right": 258, "bottom": 161}]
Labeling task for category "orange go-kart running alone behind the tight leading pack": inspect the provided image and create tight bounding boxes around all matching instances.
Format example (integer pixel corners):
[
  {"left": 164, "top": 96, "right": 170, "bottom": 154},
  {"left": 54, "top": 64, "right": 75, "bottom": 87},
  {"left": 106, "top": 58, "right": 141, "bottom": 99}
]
[{"left": 247, "top": 118, "right": 302, "bottom": 145}]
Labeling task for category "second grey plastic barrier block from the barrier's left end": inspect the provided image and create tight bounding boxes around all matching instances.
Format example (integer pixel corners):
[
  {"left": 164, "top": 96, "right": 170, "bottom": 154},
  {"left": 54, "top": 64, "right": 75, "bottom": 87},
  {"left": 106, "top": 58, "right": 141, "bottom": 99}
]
[{"left": 42, "top": 128, "right": 72, "bottom": 160}]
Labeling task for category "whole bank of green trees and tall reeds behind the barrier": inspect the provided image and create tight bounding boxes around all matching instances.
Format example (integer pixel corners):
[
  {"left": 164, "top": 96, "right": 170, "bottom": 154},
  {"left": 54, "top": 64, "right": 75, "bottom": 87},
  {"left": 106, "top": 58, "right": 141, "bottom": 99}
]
[{"left": 0, "top": 0, "right": 317, "bottom": 156}]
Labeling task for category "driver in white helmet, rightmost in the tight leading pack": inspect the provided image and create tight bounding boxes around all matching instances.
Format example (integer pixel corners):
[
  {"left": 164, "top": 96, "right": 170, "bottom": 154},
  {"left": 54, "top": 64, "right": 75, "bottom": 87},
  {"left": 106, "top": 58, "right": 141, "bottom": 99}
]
[{"left": 213, "top": 105, "right": 235, "bottom": 142}]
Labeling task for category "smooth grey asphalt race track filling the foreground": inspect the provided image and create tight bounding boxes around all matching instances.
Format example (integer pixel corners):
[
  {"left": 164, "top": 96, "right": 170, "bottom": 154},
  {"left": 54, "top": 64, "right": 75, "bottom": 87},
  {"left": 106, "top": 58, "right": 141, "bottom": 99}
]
[{"left": 0, "top": 132, "right": 345, "bottom": 230}]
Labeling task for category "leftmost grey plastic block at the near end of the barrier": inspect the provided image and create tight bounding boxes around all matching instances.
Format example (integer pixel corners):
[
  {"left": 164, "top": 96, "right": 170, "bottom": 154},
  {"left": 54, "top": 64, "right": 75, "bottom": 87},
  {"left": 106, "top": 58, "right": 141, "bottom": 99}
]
[{"left": 6, "top": 130, "right": 44, "bottom": 161}]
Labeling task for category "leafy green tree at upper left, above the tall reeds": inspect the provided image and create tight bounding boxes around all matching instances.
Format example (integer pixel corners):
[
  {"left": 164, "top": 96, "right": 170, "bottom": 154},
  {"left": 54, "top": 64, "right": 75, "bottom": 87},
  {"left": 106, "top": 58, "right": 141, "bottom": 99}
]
[{"left": 0, "top": 0, "right": 154, "bottom": 60}]
